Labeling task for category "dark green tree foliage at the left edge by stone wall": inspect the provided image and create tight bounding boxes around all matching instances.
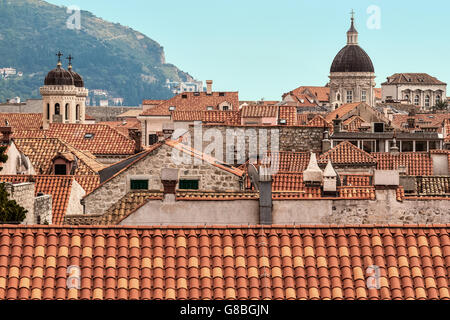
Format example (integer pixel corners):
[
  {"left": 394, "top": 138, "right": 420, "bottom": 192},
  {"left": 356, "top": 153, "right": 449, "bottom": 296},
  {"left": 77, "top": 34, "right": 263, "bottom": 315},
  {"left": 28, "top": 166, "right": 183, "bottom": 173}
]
[{"left": 0, "top": 146, "right": 27, "bottom": 223}]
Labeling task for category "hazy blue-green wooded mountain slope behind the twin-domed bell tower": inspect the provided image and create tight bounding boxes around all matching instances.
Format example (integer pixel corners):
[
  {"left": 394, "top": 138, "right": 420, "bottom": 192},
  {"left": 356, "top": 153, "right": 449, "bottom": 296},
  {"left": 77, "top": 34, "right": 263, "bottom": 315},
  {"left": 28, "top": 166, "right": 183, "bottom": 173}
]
[{"left": 0, "top": 0, "right": 191, "bottom": 105}]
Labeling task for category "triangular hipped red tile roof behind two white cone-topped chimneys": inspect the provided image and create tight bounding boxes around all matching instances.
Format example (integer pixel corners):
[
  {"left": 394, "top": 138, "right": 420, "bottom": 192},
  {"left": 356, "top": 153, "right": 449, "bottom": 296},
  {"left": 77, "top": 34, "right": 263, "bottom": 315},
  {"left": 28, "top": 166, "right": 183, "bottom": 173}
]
[{"left": 318, "top": 141, "right": 376, "bottom": 165}]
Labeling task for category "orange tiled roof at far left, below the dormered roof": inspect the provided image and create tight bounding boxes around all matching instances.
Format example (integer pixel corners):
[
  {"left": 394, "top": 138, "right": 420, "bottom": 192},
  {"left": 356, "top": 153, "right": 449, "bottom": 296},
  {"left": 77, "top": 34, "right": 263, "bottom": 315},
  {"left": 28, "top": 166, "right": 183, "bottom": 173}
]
[{"left": 0, "top": 175, "right": 74, "bottom": 225}]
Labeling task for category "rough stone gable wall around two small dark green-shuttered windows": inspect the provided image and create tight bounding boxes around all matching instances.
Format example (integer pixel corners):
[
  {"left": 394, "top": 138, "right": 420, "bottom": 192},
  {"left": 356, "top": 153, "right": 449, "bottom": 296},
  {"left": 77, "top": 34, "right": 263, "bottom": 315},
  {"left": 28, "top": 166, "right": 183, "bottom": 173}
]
[{"left": 83, "top": 145, "right": 242, "bottom": 215}]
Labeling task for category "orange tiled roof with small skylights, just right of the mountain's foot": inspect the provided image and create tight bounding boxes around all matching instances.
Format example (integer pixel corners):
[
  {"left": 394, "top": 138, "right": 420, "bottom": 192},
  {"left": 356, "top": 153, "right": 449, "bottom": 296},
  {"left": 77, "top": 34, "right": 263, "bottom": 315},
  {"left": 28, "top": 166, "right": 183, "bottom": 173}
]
[{"left": 142, "top": 92, "right": 239, "bottom": 116}]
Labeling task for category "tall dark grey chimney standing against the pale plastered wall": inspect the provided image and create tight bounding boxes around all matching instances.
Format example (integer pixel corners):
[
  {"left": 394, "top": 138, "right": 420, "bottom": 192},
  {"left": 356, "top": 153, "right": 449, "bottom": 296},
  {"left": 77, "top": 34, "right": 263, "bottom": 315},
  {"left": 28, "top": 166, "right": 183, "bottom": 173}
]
[{"left": 259, "top": 166, "right": 273, "bottom": 225}]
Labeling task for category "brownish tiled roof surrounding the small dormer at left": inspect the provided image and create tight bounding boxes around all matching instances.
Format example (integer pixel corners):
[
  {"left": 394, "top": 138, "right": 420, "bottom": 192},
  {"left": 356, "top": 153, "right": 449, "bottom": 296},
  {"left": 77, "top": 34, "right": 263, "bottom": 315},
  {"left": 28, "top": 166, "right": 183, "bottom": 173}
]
[{"left": 14, "top": 138, "right": 104, "bottom": 175}]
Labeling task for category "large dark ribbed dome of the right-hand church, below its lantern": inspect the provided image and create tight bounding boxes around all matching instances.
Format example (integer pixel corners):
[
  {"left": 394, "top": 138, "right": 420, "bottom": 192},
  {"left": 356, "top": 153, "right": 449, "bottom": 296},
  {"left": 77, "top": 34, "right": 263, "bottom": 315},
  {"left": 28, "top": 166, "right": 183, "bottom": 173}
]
[{"left": 331, "top": 45, "right": 375, "bottom": 72}]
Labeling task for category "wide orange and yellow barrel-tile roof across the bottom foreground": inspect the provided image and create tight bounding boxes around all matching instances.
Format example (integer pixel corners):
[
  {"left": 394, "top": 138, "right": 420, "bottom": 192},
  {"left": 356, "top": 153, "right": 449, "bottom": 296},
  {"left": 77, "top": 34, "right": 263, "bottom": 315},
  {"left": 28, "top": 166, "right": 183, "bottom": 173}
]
[{"left": 0, "top": 225, "right": 450, "bottom": 300}]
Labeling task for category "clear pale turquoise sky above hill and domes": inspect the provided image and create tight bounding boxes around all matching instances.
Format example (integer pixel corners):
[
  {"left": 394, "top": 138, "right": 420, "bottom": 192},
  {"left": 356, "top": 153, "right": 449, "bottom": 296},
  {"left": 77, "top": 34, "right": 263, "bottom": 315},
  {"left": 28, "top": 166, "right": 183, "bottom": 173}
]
[{"left": 49, "top": 0, "right": 450, "bottom": 100}]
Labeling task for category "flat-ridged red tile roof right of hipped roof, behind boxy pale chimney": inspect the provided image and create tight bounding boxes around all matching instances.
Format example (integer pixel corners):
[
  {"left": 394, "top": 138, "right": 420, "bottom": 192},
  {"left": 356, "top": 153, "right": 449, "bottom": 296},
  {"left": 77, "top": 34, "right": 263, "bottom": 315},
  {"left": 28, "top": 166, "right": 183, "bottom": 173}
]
[{"left": 371, "top": 152, "right": 433, "bottom": 176}]
